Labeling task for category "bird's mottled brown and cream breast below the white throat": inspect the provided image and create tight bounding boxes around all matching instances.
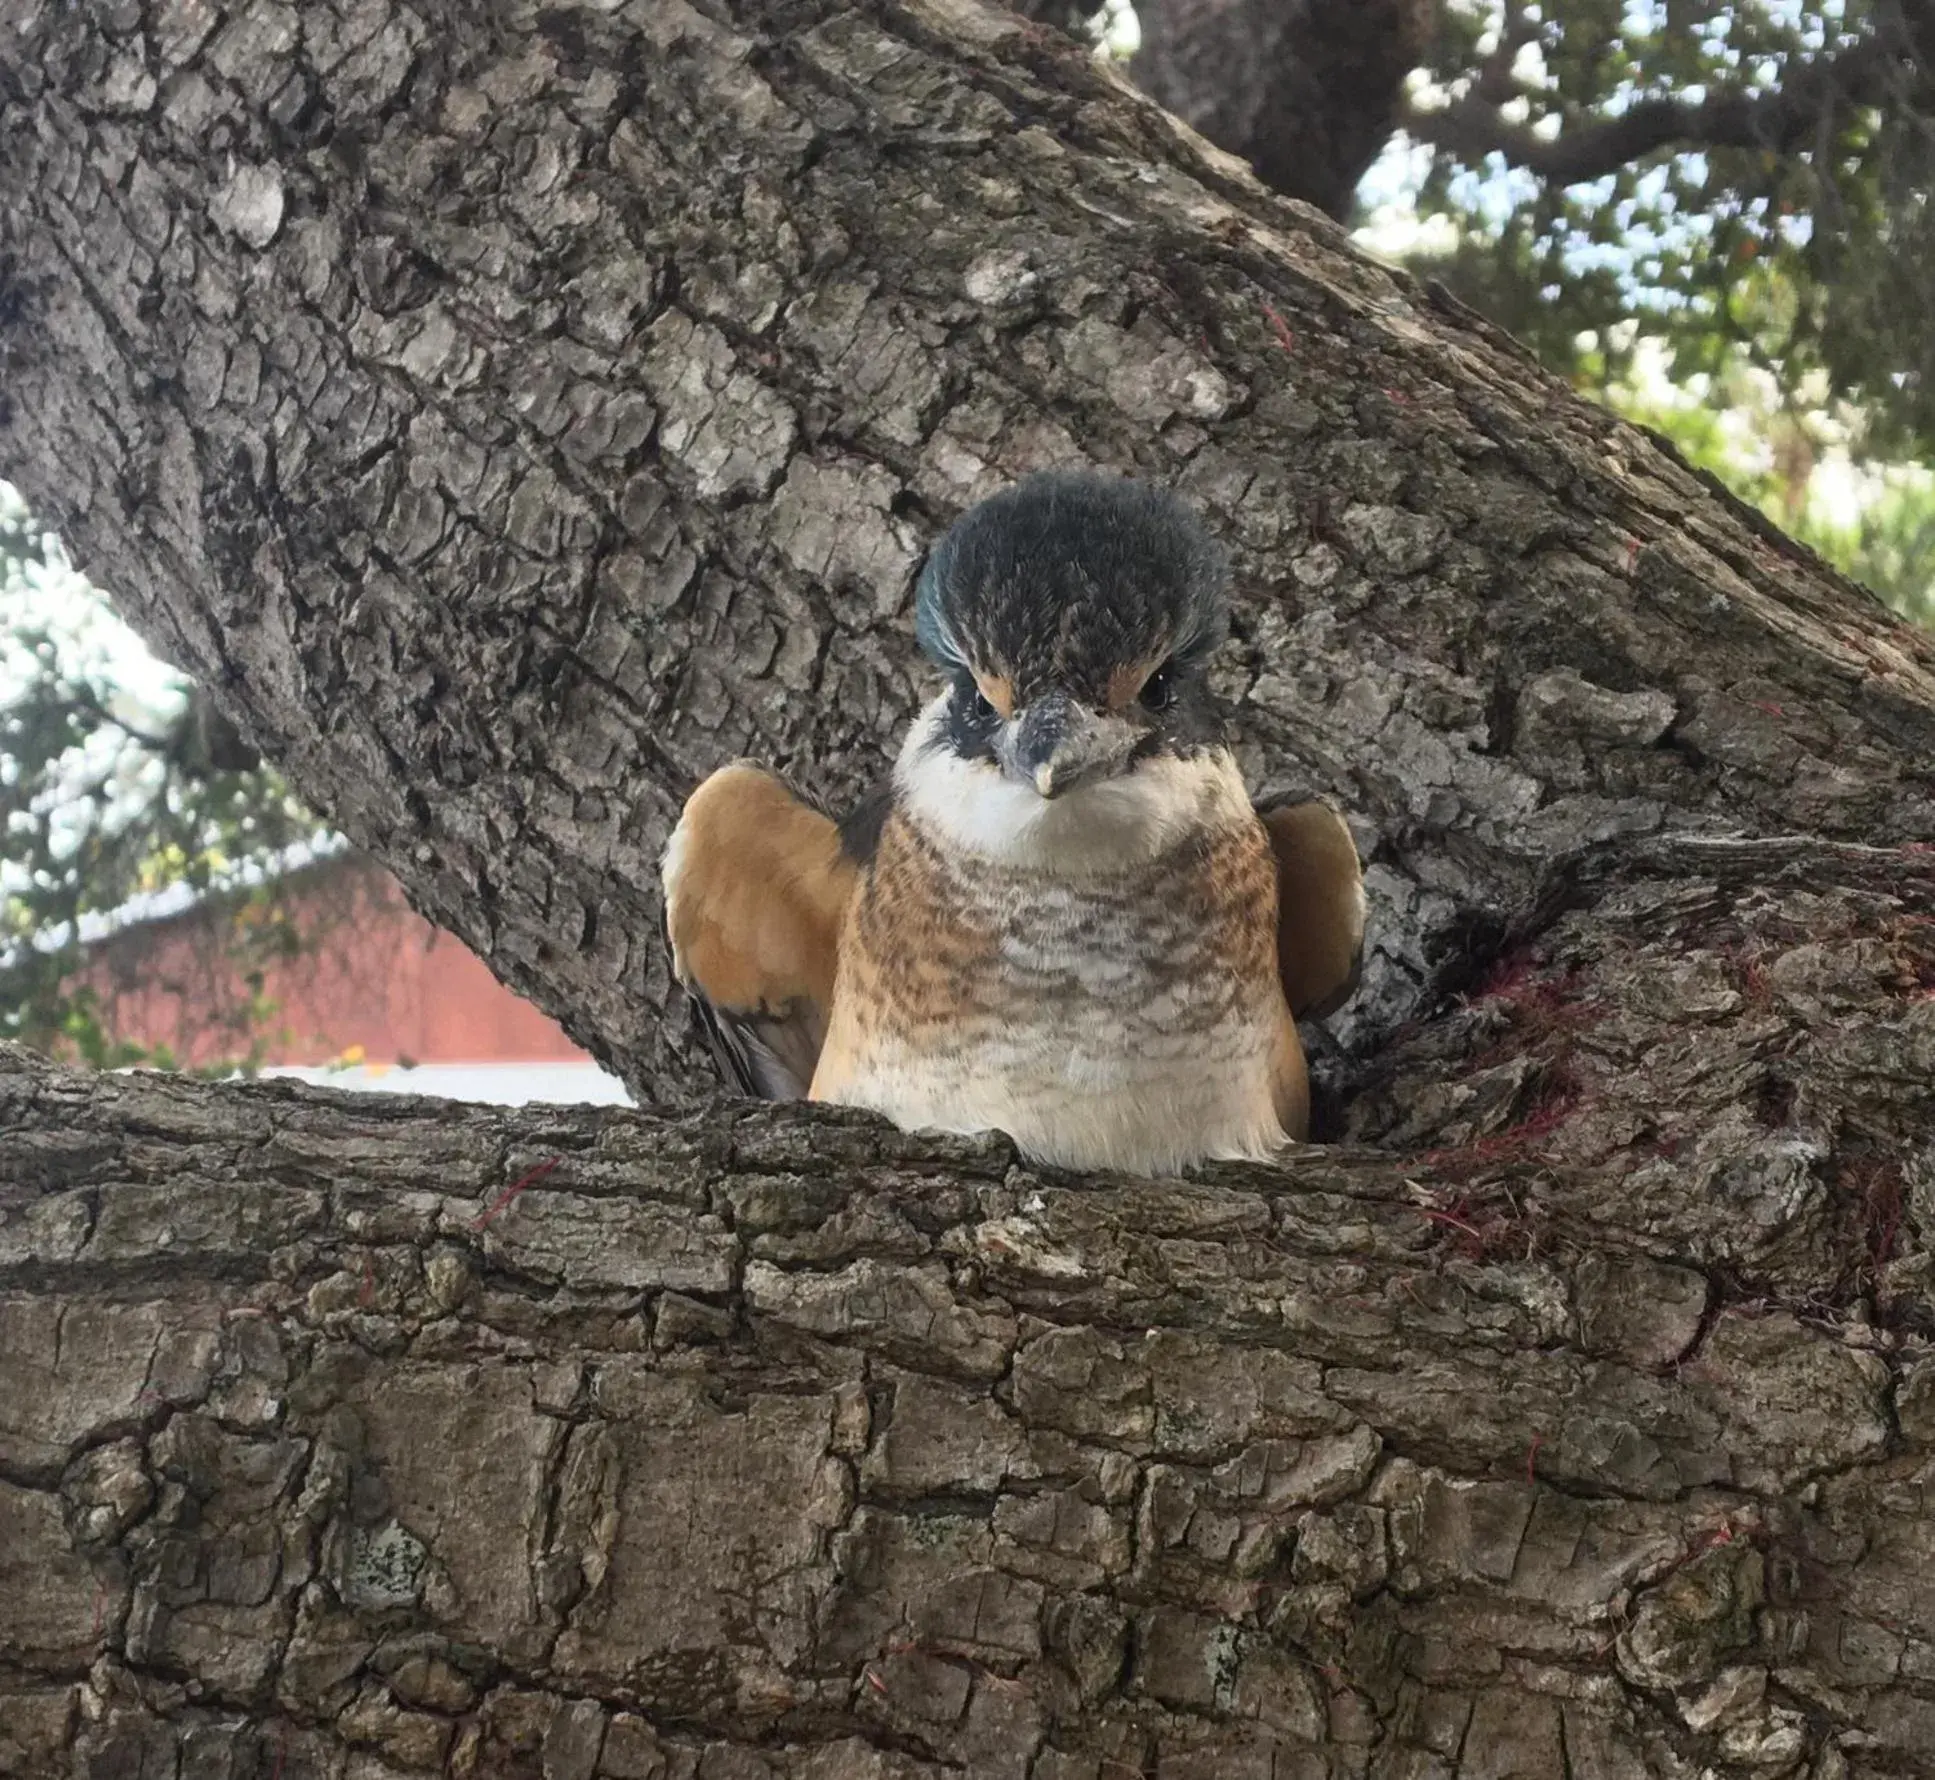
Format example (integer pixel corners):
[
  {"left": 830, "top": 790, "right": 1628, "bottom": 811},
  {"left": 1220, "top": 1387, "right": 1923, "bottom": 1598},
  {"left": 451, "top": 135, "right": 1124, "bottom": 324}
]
[{"left": 813, "top": 813, "right": 1302, "bottom": 1172}]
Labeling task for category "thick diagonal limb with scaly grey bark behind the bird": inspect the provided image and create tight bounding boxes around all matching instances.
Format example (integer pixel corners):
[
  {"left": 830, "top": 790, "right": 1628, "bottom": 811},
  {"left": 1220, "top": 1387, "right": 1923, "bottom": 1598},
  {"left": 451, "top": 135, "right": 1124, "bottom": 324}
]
[{"left": 0, "top": 0, "right": 1935, "bottom": 1097}]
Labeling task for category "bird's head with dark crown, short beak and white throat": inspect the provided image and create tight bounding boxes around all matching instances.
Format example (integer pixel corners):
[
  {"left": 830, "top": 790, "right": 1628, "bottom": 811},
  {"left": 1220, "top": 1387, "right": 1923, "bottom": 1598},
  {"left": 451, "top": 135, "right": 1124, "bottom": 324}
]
[{"left": 904, "top": 470, "right": 1229, "bottom": 866}]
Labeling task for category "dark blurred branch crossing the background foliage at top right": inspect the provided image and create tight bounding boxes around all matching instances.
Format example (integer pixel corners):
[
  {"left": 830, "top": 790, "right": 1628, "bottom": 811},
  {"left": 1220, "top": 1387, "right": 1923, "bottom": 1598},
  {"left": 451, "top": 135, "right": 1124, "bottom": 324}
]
[{"left": 1399, "top": 31, "right": 1921, "bottom": 186}]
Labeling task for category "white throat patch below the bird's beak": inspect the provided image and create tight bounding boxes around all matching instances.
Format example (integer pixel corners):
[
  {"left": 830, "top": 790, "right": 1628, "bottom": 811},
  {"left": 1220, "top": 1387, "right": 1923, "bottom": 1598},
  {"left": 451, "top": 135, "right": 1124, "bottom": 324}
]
[{"left": 894, "top": 693, "right": 1254, "bottom": 876}]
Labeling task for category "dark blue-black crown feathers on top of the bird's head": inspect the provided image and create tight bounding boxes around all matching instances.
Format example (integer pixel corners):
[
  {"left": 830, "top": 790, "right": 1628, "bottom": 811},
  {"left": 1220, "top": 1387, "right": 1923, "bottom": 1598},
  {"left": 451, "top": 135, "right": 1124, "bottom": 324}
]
[{"left": 915, "top": 470, "right": 1229, "bottom": 700}]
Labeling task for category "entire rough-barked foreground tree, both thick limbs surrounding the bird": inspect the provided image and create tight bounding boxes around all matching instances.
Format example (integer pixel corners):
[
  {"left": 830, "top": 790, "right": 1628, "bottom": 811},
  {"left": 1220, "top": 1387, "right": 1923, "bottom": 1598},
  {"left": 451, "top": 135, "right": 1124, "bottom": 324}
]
[{"left": 0, "top": 0, "right": 1935, "bottom": 1780}]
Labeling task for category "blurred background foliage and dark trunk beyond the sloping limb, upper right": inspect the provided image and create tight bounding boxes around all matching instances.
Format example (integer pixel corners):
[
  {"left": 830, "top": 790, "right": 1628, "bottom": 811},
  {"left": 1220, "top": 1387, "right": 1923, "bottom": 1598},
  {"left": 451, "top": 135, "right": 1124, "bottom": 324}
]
[{"left": 1114, "top": 0, "right": 1935, "bottom": 621}]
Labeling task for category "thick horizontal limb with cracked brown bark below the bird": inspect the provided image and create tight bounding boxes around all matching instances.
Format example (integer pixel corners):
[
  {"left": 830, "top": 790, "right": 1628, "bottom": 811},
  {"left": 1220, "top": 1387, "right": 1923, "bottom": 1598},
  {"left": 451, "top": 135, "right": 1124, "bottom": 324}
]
[{"left": 0, "top": 932, "right": 1935, "bottom": 1780}]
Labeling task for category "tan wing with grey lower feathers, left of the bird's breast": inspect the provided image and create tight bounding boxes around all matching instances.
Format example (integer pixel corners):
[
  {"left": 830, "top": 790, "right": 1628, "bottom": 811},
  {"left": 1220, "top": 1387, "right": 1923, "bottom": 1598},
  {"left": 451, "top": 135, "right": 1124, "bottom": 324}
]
[{"left": 664, "top": 760, "right": 859, "bottom": 1101}]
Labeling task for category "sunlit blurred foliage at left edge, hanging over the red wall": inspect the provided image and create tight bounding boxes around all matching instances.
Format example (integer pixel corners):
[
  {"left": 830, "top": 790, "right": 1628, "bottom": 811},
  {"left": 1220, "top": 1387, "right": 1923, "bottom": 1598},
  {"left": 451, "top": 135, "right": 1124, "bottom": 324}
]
[{"left": 0, "top": 507, "right": 315, "bottom": 1068}]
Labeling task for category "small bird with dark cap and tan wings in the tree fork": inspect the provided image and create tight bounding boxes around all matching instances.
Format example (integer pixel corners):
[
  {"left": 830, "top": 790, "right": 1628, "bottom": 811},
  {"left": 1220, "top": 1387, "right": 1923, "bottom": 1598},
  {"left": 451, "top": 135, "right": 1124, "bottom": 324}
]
[{"left": 662, "top": 470, "right": 1366, "bottom": 1176}]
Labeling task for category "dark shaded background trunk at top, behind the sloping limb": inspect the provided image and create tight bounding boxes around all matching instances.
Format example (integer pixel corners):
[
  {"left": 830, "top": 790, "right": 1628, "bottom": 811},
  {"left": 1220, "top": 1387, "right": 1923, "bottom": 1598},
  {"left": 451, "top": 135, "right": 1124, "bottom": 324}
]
[{"left": 1132, "top": 0, "right": 1438, "bottom": 217}]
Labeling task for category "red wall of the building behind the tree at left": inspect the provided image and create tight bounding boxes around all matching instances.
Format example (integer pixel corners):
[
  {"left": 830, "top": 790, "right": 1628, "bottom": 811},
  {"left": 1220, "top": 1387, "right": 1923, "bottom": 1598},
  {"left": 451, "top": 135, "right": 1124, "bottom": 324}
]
[{"left": 87, "top": 859, "right": 584, "bottom": 1066}]
